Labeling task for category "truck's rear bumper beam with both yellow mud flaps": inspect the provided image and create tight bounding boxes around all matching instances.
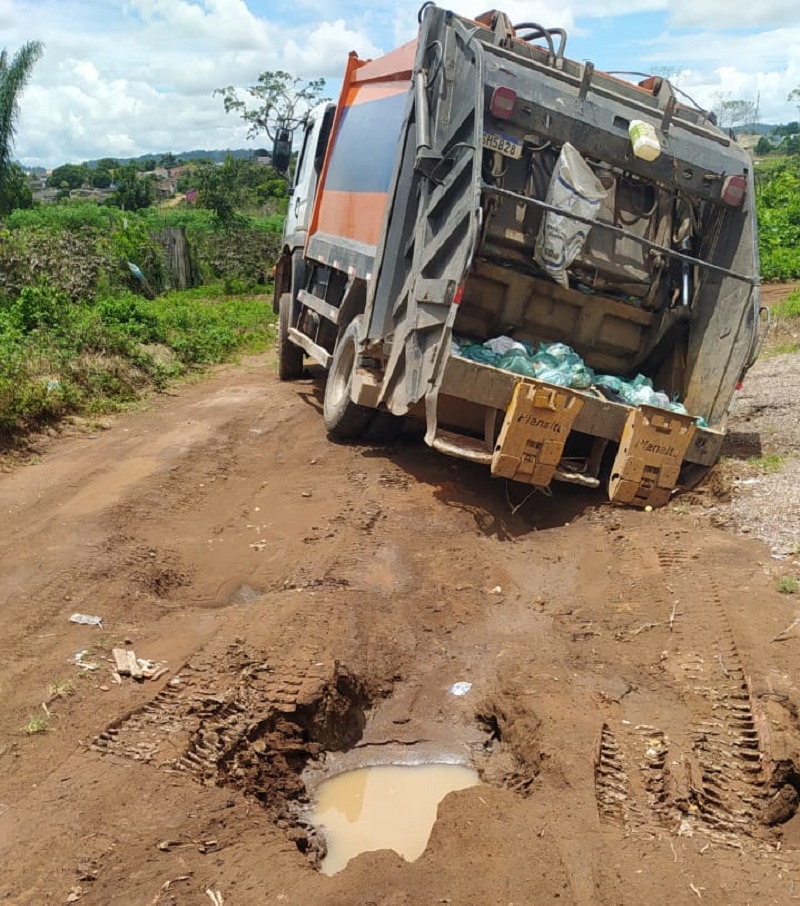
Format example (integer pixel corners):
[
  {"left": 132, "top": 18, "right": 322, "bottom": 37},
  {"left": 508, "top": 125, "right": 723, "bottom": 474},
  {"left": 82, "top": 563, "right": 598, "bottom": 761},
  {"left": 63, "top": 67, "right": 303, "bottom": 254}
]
[{"left": 429, "top": 356, "right": 724, "bottom": 506}]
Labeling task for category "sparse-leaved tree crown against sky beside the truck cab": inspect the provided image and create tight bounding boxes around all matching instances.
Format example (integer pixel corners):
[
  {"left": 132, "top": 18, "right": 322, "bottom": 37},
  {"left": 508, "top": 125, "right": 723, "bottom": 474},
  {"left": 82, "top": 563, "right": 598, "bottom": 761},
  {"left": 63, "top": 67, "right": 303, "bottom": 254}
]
[{"left": 214, "top": 70, "right": 325, "bottom": 140}]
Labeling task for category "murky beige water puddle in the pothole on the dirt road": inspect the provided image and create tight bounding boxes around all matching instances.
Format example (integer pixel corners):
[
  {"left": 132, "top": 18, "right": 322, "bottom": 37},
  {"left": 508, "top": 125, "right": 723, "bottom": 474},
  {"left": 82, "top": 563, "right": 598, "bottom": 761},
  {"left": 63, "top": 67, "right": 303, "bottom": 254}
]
[{"left": 311, "top": 764, "right": 478, "bottom": 875}]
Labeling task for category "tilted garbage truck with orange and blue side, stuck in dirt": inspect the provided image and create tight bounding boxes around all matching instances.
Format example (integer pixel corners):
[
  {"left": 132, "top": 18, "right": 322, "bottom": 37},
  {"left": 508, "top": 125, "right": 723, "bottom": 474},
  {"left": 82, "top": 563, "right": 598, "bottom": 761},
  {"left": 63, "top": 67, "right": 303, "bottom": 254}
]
[{"left": 274, "top": 3, "right": 760, "bottom": 507}]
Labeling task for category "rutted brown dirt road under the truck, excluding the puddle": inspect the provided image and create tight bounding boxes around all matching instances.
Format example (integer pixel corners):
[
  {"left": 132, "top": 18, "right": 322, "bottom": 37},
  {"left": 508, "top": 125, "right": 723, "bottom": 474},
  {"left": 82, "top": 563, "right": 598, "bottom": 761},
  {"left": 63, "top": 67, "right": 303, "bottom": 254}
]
[{"left": 0, "top": 350, "right": 800, "bottom": 906}]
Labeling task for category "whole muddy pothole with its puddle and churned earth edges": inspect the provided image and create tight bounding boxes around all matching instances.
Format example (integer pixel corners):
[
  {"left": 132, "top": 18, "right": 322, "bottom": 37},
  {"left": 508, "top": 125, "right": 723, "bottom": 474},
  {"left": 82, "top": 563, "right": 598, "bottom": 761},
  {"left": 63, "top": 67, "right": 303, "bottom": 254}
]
[{"left": 92, "top": 641, "right": 538, "bottom": 872}]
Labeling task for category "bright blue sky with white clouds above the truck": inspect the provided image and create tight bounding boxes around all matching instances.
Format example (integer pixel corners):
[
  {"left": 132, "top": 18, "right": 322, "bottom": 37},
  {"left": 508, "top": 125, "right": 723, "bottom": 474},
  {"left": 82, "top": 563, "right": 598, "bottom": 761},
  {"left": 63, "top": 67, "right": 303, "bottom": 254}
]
[{"left": 0, "top": 0, "right": 800, "bottom": 167}]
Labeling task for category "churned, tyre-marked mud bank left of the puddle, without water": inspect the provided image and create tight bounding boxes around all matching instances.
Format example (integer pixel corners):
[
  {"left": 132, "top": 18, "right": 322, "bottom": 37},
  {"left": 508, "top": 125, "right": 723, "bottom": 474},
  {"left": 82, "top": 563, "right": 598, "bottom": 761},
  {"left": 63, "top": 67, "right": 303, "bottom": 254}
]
[{"left": 92, "top": 645, "right": 371, "bottom": 864}]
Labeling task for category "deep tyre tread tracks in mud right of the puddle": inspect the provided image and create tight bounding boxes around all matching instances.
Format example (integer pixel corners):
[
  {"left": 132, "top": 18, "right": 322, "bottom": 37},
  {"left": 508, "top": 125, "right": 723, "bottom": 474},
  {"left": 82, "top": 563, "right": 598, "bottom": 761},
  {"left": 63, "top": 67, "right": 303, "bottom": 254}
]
[{"left": 595, "top": 542, "right": 792, "bottom": 848}]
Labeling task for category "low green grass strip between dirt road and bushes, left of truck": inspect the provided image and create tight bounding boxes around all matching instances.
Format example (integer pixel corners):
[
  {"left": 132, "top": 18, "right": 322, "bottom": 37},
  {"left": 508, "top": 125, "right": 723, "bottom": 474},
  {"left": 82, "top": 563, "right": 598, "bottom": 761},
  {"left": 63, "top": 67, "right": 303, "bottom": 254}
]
[{"left": 0, "top": 284, "right": 274, "bottom": 445}]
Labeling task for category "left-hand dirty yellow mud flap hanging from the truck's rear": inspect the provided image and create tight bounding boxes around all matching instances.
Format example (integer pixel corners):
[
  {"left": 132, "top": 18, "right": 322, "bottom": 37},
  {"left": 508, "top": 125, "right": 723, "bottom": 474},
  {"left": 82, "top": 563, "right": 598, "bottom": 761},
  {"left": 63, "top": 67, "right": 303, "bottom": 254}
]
[{"left": 492, "top": 383, "right": 583, "bottom": 487}]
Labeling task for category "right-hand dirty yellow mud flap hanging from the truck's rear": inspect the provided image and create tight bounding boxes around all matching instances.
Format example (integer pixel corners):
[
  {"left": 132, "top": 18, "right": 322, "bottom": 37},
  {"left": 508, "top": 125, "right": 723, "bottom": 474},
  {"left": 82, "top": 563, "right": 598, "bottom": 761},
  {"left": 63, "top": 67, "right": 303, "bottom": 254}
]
[{"left": 608, "top": 406, "right": 695, "bottom": 507}]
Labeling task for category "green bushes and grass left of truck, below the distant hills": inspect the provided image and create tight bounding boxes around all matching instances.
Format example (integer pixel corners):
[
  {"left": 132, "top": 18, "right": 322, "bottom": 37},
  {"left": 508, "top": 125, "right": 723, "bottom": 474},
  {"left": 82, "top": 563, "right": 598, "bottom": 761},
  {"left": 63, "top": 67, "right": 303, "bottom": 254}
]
[{"left": 0, "top": 204, "right": 281, "bottom": 446}]
